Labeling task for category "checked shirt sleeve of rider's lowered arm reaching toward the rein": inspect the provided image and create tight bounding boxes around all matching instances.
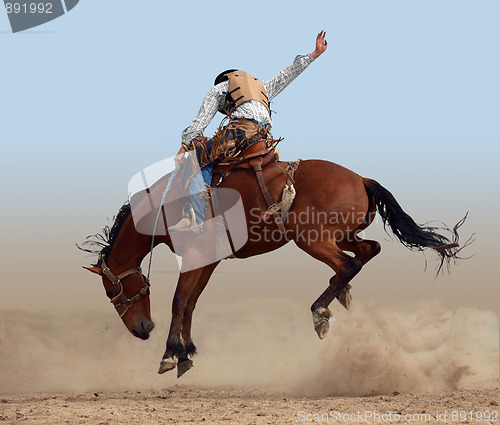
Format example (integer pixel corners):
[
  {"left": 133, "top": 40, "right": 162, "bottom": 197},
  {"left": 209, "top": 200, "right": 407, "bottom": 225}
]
[{"left": 181, "top": 81, "right": 229, "bottom": 146}]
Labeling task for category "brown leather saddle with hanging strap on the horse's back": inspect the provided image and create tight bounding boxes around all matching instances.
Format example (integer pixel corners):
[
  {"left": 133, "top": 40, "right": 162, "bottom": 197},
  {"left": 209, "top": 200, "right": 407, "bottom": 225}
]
[{"left": 212, "top": 140, "right": 300, "bottom": 234}]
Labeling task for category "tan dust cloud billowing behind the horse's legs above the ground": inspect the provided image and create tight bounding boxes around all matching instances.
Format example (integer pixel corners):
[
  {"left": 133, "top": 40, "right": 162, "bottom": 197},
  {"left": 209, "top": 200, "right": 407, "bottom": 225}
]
[{"left": 0, "top": 298, "right": 499, "bottom": 397}]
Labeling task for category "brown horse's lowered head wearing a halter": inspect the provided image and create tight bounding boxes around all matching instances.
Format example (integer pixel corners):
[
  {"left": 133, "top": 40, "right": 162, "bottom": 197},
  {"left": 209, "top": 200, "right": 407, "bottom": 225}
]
[{"left": 85, "top": 259, "right": 155, "bottom": 339}]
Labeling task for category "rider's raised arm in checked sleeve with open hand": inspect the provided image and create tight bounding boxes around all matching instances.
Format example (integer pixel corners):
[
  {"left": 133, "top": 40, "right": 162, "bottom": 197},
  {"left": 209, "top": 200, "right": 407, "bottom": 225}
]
[{"left": 264, "top": 31, "right": 327, "bottom": 100}]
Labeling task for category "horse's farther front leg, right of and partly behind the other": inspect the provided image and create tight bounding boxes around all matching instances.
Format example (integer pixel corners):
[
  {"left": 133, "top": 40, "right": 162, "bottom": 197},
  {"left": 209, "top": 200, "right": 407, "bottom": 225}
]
[{"left": 177, "top": 261, "right": 220, "bottom": 378}]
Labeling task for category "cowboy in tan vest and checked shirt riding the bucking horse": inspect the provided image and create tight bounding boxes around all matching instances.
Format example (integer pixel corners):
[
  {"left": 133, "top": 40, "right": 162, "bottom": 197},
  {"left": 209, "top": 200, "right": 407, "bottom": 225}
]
[{"left": 169, "top": 31, "right": 327, "bottom": 233}]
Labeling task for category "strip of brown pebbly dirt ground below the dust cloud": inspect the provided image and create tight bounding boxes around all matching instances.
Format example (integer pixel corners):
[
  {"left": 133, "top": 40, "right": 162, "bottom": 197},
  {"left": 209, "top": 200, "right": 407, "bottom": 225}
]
[{"left": 0, "top": 385, "right": 498, "bottom": 425}]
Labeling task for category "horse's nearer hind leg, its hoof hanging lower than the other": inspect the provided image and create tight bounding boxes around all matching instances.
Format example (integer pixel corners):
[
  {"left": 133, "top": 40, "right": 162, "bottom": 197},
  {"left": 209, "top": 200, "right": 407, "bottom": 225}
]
[{"left": 297, "top": 239, "right": 363, "bottom": 339}]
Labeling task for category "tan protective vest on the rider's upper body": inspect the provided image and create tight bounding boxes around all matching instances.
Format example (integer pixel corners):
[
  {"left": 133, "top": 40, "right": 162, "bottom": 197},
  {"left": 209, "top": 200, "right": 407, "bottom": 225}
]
[{"left": 221, "top": 71, "right": 271, "bottom": 115}]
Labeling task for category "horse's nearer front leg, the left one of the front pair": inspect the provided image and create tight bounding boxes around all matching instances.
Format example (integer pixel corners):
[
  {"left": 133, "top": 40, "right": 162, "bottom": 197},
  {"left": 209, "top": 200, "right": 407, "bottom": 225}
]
[{"left": 158, "top": 268, "right": 203, "bottom": 373}]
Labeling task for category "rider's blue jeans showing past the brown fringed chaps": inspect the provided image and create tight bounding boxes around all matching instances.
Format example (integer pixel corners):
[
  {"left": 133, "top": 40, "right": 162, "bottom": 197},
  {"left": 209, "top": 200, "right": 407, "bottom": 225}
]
[{"left": 189, "top": 120, "right": 266, "bottom": 223}]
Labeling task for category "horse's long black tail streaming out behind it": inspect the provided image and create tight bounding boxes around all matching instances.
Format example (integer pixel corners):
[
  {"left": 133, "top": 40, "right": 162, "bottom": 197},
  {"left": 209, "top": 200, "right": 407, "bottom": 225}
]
[{"left": 363, "top": 178, "right": 472, "bottom": 273}]
